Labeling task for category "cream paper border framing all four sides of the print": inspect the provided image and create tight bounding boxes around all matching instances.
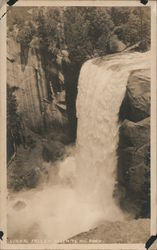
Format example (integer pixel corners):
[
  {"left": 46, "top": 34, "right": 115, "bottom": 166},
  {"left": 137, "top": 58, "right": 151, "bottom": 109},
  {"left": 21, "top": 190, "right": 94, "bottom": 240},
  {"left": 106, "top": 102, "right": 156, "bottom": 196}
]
[{"left": 0, "top": 0, "right": 157, "bottom": 250}]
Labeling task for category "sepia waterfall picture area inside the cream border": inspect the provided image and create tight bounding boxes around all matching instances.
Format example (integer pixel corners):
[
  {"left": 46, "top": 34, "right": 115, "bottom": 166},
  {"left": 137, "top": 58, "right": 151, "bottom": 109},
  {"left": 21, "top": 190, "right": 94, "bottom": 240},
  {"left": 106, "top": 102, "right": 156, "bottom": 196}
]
[{"left": 0, "top": 0, "right": 154, "bottom": 249}]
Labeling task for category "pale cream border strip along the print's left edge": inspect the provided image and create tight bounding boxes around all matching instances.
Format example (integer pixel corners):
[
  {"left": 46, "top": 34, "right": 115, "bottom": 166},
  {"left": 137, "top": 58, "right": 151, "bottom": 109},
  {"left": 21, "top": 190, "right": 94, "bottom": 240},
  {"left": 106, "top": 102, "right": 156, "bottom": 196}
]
[{"left": 0, "top": 2, "right": 7, "bottom": 249}]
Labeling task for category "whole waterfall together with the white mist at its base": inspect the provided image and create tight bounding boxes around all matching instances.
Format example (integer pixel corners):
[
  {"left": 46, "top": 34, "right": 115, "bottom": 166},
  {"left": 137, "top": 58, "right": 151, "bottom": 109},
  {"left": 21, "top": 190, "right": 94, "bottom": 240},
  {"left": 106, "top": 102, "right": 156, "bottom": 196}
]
[{"left": 8, "top": 52, "right": 150, "bottom": 242}]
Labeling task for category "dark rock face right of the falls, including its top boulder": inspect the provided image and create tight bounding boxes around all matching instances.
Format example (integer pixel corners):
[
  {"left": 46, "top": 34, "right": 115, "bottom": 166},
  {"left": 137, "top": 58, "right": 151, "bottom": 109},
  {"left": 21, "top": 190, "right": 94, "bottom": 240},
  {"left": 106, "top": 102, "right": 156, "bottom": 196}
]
[{"left": 117, "top": 70, "right": 150, "bottom": 217}]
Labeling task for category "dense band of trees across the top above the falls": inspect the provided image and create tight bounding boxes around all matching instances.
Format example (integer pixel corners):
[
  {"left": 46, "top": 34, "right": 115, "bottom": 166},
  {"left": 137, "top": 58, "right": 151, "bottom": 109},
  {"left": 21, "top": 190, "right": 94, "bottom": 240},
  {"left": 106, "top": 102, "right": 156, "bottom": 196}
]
[{"left": 8, "top": 7, "right": 150, "bottom": 62}]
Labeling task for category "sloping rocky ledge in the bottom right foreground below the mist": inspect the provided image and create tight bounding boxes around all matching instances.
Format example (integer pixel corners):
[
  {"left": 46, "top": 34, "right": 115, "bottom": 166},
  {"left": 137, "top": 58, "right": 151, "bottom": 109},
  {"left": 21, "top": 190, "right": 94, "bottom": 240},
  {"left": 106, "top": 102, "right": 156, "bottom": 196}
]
[{"left": 69, "top": 219, "right": 150, "bottom": 244}]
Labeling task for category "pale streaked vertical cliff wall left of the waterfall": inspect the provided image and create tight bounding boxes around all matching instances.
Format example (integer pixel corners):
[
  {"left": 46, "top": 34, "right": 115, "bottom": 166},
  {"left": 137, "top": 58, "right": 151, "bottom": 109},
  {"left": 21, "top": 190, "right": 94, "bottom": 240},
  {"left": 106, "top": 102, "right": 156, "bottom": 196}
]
[{"left": 7, "top": 37, "right": 65, "bottom": 131}]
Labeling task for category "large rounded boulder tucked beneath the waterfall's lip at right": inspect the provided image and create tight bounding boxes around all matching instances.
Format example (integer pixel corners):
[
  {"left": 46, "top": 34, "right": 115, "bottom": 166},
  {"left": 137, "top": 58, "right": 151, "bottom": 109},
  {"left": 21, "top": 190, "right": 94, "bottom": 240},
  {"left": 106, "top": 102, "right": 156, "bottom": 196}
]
[{"left": 120, "top": 69, "right": 150, "bottom": 122}]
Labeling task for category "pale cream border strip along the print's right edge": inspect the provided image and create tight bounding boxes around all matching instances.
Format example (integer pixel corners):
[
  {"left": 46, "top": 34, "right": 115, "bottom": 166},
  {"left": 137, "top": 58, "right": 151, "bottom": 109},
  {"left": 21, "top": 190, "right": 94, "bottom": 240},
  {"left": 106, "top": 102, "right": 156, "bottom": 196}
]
[{"left": 151, "top": 1, "right": 157, "bottom": 235}]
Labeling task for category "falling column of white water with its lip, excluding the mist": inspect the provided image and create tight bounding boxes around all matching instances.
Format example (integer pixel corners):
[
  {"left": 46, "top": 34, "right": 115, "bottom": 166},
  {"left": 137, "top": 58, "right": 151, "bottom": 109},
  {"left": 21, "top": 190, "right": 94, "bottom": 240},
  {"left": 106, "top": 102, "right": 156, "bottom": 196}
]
[{"left": 76, "top": 52, "right": 150, "bottom": 220}]
